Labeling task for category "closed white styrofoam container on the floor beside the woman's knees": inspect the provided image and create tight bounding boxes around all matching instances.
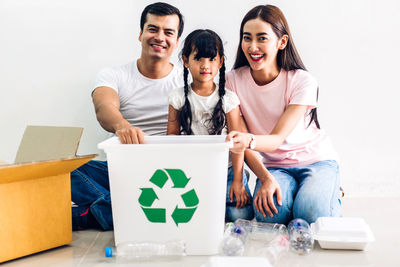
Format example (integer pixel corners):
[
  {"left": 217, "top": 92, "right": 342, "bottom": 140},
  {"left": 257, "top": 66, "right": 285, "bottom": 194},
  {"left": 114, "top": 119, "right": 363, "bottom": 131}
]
[{"left": 311, "top": 217, "right": 375, "bottom": 250}]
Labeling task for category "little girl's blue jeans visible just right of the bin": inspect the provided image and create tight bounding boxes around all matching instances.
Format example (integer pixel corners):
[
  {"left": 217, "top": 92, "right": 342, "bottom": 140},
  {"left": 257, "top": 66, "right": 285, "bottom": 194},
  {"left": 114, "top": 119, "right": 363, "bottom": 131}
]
[{"left": 225, "top": 166, "right": 254, "bottom": 222}]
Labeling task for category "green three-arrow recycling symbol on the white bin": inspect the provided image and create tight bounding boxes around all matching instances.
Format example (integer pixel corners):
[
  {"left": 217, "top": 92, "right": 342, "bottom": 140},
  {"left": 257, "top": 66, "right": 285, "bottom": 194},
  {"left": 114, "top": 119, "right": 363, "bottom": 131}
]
[{"left": 139, "top": 169, "right": 199, "bottom": 226}]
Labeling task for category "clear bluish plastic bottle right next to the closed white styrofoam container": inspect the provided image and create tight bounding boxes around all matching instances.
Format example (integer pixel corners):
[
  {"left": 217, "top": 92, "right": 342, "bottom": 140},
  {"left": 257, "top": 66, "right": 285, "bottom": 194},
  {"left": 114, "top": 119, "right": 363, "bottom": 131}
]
[{"left": 288, "top": 218, "right": 314, "bottom": 255}]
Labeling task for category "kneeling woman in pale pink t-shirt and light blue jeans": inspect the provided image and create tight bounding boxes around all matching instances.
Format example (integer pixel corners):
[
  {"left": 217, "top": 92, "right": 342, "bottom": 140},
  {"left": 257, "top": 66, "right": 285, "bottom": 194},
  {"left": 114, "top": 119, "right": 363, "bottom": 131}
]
[{"left": 227, "top": 5, "right": 341, "bottom": 223}]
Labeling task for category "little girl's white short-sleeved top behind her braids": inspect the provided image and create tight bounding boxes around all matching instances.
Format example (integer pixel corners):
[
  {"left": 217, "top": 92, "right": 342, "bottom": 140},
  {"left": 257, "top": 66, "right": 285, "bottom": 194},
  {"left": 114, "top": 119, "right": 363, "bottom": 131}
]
[{"left": 168, "top": 85, "right": 240, "bottom": 135}]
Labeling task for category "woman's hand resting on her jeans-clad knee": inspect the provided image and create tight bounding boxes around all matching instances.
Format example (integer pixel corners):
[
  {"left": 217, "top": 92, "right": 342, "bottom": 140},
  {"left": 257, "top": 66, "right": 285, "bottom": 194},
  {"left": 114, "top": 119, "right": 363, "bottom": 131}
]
[{"left": 254, "top": 177, "right": 282, "bottom": 217}]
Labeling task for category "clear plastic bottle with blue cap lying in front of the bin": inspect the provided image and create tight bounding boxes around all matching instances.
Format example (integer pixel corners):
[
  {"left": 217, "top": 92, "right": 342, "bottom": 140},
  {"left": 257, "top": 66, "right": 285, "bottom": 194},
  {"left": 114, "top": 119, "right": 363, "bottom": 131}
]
[{"left": 105, "top": 240, "right": 186, "bottom": 259}]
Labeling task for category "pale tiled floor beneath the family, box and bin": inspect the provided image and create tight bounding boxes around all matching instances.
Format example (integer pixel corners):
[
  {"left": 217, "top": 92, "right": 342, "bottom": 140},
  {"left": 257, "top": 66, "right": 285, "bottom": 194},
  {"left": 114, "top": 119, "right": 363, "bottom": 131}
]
[{"left": 2, "top": 198, "right": 400, "bottom": 267}]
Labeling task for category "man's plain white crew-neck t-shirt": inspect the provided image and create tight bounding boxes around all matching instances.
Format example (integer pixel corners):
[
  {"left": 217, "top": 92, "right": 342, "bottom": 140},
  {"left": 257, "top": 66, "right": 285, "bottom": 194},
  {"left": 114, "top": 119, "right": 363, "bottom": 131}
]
[{"left": 94, "top": 61, "right": 183, "bottom": 135}]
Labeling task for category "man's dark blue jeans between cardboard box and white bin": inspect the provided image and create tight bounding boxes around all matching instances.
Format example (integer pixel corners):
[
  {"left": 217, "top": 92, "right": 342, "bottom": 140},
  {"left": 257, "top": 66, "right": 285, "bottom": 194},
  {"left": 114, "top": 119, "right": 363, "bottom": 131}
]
[{"left": 71, "top": 160, "right": 113, "bottom": 230}]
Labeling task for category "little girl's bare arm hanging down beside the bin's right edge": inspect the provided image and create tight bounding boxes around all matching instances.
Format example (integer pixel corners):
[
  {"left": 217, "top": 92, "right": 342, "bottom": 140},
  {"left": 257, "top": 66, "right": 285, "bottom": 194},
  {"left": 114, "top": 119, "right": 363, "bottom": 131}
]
[{"left": 226, "top": 106, "right": 250, "bottom": 209}]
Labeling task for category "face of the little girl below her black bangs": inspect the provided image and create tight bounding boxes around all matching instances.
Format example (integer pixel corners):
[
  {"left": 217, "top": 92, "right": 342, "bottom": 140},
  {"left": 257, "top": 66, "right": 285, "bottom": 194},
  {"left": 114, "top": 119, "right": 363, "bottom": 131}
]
[{"left": 183, "top": 51, "right": 224, "bottom": 86}]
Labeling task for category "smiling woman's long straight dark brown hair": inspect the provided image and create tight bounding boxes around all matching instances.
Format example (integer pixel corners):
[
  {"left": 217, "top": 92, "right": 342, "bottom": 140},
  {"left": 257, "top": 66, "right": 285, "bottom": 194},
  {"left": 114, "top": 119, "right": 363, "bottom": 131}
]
[{"left": 233, "top": 5, "right": 320, "bottom": 129}]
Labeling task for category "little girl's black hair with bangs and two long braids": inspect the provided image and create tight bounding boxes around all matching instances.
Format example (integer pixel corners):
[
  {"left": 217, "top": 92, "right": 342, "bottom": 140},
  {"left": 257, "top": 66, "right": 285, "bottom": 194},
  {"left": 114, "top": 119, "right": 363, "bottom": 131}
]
[{"left": 179, "top": 29, "right": 226, "bottom": 135}]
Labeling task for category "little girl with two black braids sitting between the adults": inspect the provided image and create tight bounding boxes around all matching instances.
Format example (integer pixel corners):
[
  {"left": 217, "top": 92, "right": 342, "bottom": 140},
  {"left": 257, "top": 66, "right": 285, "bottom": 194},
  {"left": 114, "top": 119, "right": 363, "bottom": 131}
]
[{"left": 167, "top": 30, "right": 254, "bottom": 221}]
